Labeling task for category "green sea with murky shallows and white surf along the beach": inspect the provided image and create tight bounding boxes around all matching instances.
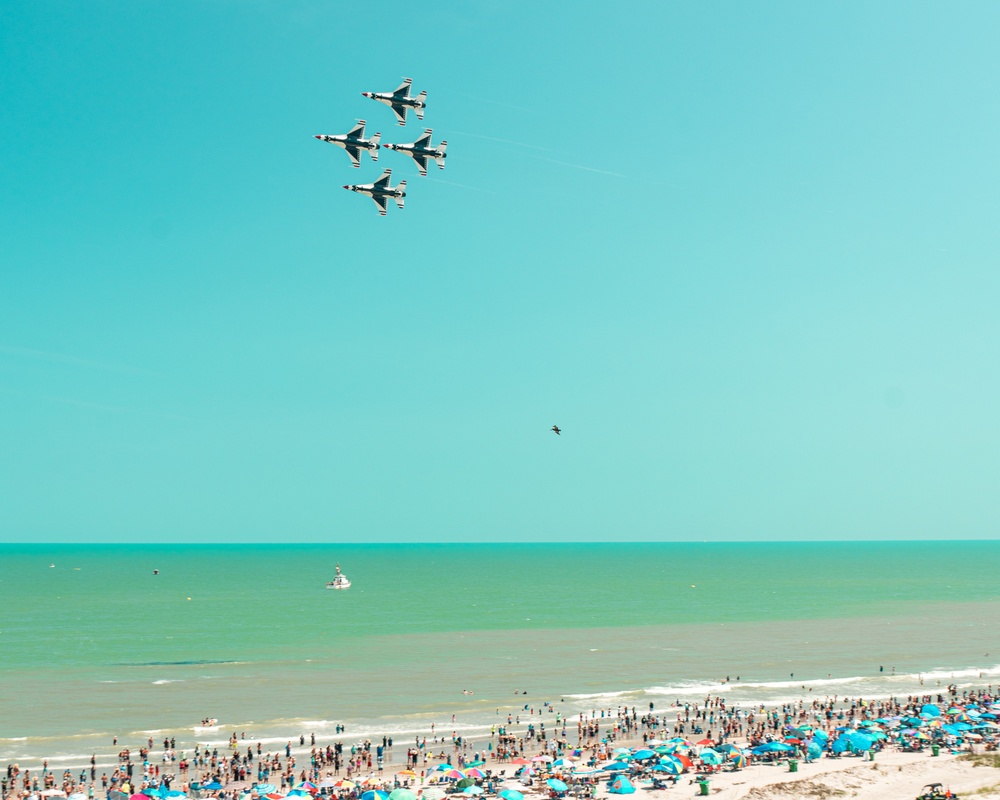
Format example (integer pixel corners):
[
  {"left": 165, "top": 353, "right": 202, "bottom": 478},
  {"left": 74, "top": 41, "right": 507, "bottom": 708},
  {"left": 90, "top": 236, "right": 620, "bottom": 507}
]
[{"left": 0, "top": 541, "right": 1000, "bottom": 768}]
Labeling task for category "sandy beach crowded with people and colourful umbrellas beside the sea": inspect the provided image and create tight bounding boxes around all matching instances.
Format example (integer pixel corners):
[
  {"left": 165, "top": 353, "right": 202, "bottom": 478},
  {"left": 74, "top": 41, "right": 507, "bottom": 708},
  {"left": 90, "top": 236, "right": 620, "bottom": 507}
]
[{"left": 3, "top": 688, "right": 1000, "bottom": 800}]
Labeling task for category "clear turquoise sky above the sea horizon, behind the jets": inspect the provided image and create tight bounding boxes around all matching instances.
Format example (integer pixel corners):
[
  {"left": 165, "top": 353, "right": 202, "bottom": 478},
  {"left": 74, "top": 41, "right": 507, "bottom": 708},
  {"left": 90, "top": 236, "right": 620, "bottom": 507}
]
[{"left": 0, "top": 0, "right": 1000, "bottom": 542}]
